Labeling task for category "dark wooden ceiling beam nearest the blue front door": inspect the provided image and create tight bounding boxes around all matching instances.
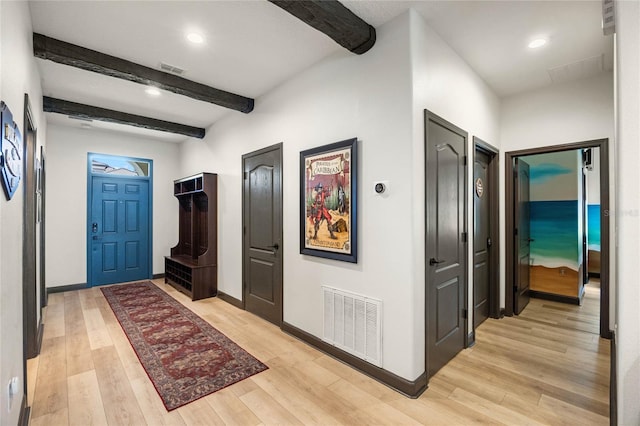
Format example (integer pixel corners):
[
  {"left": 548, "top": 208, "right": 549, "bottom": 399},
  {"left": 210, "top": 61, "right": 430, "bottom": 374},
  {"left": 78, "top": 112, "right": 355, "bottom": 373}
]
[{"left": 42, "top": 96, "right": 205, "bottom": 139}]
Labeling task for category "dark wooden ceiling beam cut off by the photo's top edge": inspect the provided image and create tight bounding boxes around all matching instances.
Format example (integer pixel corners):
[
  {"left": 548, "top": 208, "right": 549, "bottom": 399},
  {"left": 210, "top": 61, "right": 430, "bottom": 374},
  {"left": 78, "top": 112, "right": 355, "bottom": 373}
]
[{"left": 269, "top": 0, "right": 376, "bottom": 55}]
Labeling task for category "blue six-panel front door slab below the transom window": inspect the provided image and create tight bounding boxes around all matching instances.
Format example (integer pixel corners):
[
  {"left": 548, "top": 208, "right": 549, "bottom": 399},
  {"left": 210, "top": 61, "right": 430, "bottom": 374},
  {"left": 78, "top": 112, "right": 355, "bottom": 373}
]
[{"left": 88, "top": 175, "right": 151, "bottom": 286}]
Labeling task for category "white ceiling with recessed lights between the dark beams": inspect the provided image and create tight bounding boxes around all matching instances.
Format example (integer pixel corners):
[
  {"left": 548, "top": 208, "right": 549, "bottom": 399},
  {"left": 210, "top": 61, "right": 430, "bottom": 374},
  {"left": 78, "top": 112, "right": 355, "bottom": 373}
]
[{"left": 30, "top": 0, "right": 613, "bottom": 142}]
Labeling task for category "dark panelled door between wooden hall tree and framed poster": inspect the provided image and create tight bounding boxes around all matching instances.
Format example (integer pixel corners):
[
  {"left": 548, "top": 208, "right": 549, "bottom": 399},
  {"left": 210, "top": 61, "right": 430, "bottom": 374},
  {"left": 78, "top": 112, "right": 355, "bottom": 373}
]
[{"left": 242, "top": 145, "right": 282, "bottom": 325}]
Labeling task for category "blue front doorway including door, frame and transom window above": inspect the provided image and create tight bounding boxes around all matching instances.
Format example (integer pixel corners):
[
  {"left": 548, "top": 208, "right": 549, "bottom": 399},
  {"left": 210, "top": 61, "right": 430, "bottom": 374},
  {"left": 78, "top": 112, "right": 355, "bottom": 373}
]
[{"left": 87, "top": 153, "right": 153, "bottom": 287}]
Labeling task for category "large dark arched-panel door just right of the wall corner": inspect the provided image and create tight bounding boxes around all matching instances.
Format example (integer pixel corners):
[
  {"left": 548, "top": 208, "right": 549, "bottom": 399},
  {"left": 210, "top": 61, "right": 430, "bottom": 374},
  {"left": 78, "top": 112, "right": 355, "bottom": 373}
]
[{"left": 425, "top": 112, "right": 467, "bottom": 376}]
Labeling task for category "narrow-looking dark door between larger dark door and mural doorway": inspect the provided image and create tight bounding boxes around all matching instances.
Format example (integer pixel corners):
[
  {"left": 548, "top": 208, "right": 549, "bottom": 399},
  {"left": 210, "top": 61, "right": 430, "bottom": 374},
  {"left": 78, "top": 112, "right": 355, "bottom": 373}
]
[{"left": 473, "top": 150, "right": 493, "bottom": 328}]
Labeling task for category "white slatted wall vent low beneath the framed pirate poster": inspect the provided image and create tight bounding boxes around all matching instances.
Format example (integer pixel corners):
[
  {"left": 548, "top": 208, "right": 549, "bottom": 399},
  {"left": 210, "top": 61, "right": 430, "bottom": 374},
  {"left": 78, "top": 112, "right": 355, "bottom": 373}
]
[{"left": 322, "top": 286, "right": 382, "bottom": 367}]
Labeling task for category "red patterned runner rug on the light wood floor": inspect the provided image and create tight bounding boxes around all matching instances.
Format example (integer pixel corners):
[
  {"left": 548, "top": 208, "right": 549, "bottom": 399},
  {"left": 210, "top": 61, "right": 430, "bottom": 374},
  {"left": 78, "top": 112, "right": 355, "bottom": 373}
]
[{"left": 101, "top": 281, "right": 268, "bottom": 411}]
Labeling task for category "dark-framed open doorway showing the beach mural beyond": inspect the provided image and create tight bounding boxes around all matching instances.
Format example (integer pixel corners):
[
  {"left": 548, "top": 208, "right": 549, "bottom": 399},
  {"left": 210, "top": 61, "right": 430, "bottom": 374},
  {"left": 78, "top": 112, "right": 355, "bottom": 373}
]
[{"left": 505, "top": 139, "right": 611, "bottom": 339}]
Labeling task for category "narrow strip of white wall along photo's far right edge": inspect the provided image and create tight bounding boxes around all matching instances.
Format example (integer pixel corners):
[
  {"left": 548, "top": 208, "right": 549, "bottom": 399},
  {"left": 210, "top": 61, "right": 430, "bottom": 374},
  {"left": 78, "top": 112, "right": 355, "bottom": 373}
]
[{"left": 615, "top": 1, "right": 640, "bottom": 425}]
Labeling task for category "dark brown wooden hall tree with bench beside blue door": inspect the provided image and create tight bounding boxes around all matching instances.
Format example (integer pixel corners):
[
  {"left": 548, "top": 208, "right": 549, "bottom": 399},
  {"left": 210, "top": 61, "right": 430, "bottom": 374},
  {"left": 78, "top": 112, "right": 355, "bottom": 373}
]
[{"left": 164, "top": 173, "right": 218, "bottom": 300}]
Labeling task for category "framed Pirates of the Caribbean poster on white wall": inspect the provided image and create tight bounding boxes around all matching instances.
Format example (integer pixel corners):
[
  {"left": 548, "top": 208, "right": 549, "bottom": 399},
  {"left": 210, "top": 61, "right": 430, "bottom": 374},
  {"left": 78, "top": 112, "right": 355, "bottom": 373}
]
[{"left": 300, "top": 138, "right": 358, "bottom": 263}]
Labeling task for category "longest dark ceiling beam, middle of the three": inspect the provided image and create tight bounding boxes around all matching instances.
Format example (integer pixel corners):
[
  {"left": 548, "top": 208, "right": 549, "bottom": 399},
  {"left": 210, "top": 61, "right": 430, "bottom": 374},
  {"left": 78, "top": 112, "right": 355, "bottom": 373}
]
[{"left": 33, "top": 33, "right": 254, "bottom": 113}]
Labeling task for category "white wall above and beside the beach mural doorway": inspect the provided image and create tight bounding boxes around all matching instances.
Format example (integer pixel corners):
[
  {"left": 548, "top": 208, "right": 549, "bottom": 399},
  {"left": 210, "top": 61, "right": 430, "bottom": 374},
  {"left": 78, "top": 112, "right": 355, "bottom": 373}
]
[{"left": 500, "top": 73, "right": 616, "bottom": 312}]
